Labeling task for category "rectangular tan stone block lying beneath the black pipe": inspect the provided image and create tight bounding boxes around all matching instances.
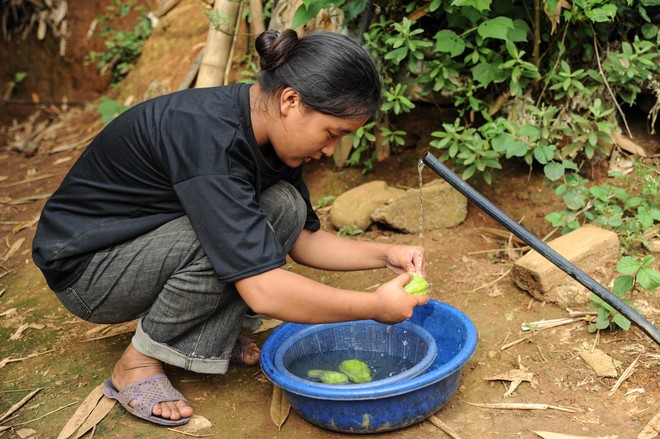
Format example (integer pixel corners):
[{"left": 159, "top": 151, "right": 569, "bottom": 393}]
[{"left": 512, "top": 225, "right": 619, "bottom": 307}]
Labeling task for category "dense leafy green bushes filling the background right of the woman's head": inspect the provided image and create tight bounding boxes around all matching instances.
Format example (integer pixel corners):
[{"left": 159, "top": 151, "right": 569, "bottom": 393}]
[{"left": 296, "top": 0, "right": 660, "bottom": 181}]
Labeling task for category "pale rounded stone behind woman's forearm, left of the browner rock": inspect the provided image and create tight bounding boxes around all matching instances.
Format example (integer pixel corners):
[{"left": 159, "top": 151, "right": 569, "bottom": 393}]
[{"left": 330, "top": 180, "right": 405, "bottom": 230}]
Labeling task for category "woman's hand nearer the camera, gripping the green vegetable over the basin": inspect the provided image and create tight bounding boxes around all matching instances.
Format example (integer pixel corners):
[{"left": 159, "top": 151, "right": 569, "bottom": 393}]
[{"left": 373, "top": 273, "right": 429, "bottom": 324}]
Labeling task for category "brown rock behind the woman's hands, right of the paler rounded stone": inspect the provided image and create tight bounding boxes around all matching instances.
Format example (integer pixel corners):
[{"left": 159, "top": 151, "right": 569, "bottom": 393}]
[{"left": 371, "top": 179, "right": 467, "bottom": 233}]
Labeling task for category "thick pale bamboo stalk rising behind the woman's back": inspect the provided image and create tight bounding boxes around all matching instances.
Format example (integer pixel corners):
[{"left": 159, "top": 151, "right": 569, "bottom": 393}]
[{"left": 195, "top": 0, "right": 239, "bottom": 88}]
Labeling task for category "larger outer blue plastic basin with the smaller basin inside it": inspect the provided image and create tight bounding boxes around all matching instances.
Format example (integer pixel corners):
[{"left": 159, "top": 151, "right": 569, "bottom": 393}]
[{"left": 261, "top": 300, "right": 477, "bottom": 433}]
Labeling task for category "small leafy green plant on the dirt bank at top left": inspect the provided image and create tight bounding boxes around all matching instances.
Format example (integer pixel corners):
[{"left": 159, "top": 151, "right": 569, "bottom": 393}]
[{"left": 87, "top": 0, "right": 152, "bottom": 85}]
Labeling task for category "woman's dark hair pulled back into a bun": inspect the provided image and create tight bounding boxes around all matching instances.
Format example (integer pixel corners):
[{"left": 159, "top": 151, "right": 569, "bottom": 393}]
[{"left": 255, "top": 29, "right": 381, "bottom": 118}]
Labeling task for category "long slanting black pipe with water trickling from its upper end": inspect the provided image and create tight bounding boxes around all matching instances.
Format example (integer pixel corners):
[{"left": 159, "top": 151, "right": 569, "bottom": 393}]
[{"left": 420, "top": 152, "right": 660, "bottom": 345}]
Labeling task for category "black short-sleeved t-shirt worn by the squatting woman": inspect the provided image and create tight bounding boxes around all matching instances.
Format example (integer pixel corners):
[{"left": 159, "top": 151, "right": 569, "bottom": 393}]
[{"left": 32, "top": 84, "right": 320, "bottom": 291}]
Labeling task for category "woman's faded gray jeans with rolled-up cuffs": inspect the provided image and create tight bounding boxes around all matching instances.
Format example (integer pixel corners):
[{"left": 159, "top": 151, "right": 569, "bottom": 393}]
[{"left": 56, "top": 182, "right": 306, "bottom": 373}]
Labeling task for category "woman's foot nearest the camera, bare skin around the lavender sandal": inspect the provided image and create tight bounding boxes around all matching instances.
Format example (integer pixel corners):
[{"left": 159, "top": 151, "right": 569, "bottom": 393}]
[{"left": 112, "top": 344, "right": 193, "bottom": 421}]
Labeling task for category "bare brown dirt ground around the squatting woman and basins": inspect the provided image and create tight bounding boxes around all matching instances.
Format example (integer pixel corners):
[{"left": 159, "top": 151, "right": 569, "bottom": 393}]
[{"left": 0, "top": 1, "right": 660, "bottom": 439}]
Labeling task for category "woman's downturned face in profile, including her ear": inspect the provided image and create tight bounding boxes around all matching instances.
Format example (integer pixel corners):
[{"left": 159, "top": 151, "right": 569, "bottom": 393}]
[{"left": 268, "top": 88, "right": 368, "bottom": 168}]
